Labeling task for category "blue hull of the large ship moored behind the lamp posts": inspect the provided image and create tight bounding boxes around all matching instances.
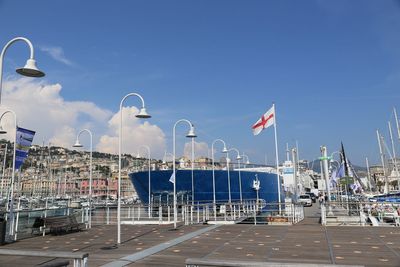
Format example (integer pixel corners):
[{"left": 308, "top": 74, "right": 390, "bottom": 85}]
[{"left": 129, "top": 170, "right": 285, "bottom": 203}]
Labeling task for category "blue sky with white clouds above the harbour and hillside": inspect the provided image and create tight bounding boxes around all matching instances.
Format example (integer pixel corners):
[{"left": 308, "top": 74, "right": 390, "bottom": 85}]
[{"left": 0, "top": 0, "right": 400, "bottom": 166}]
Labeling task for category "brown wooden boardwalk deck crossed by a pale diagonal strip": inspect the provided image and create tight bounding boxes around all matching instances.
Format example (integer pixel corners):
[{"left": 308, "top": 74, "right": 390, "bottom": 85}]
[{"left": 0, "top": 205, "right": 400, "bottom": 267}]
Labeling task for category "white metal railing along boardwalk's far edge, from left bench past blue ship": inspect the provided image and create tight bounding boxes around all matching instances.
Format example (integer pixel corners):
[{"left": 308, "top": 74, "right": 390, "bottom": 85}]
[{"left": 3, "top": 200, "right": 304, "bottom": 244}]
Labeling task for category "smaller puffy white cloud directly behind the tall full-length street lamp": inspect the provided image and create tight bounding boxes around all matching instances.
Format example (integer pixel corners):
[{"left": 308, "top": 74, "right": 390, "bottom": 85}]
[{"left": 97, "top": 107, "right": 165, "bottom": 158}]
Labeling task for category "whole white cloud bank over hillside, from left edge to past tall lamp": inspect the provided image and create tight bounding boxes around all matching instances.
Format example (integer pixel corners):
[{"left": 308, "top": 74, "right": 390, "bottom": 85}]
[{"left": 0, "top": 78, "right": 165, "bottom": 158}]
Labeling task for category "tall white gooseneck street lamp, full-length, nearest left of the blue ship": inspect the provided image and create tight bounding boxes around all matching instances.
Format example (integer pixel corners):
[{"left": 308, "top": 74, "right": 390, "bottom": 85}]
[{"left": 117, "top": 93, "right": 151, "bottom": 244}]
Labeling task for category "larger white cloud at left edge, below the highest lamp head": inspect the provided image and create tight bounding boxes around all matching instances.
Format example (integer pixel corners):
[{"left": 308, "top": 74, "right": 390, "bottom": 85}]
[{"left": 2, "top": 78, "right": 112, "bottom": 148}]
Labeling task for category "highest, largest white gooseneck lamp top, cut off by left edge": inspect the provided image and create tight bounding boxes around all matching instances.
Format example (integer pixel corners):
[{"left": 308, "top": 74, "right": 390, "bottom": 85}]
[{"left": 0, "top": 37, "right": 44, "bottom": 104}]
